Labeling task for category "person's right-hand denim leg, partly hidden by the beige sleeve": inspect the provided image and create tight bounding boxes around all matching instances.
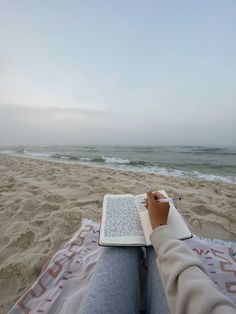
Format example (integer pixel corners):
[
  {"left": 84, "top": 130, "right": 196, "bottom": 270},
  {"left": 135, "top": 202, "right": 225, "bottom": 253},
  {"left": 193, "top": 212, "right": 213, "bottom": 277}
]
[{"left": 146, "top": 247, "right": 170, "bottom": 314}]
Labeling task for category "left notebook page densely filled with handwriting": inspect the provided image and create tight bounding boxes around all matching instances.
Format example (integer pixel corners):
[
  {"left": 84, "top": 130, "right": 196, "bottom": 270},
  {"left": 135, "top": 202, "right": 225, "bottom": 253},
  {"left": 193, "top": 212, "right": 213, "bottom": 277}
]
[{"left": 100, "top": 194, "right": 145, "bottom": 245}]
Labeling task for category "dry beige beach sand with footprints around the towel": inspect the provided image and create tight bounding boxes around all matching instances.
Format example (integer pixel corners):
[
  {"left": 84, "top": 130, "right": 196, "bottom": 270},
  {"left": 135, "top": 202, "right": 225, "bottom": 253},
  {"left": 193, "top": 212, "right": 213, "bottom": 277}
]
[{"left": 0, "top": 155, "right": 236, "bottom": 313}]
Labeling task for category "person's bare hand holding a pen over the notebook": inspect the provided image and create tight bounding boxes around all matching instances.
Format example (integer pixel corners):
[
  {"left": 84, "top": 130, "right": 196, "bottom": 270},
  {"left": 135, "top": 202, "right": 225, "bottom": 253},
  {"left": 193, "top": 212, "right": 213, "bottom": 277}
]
[{"left": 146, "top": 192, "right": 170, "bottom": 229}]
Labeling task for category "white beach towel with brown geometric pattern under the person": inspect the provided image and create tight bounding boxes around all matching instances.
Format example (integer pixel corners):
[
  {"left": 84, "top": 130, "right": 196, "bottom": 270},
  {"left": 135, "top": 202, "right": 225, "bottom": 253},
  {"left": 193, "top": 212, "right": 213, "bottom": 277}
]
[{"left": 8, "top": 219, "right": 236, "bottom": 314}]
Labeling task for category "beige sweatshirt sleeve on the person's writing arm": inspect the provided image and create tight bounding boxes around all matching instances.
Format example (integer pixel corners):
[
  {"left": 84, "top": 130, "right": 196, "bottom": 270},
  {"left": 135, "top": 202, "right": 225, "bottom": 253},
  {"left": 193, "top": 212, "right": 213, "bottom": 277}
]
[{"left": 150, "top": 226, "right": 236, "bottom": 314}]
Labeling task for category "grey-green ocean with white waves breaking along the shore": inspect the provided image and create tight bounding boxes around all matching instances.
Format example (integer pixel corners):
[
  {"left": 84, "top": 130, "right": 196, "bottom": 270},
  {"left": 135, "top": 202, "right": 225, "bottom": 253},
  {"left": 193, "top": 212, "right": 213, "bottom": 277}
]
[{"left": 0, "top": 146, "right": 236, "bottom": 184}]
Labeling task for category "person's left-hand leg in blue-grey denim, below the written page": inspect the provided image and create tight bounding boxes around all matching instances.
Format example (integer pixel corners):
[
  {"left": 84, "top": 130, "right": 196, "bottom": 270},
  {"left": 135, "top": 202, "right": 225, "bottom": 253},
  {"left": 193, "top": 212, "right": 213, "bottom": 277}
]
[{"left": 79, "top": 247, "right": 142, "bottom": 314}]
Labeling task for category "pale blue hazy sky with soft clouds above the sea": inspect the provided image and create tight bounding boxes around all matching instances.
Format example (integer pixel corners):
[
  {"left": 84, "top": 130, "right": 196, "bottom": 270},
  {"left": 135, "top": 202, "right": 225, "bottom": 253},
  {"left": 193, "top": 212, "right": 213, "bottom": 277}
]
[{"left": 0, "top": 0, "right": 236, "bottom": 146}]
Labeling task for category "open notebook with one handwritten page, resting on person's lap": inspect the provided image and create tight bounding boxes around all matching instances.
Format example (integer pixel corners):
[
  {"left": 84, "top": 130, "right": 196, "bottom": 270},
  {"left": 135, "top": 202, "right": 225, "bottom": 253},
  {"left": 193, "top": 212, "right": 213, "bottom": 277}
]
[{"left": 99, "top": 191, "right": 192, "bottom": 246}]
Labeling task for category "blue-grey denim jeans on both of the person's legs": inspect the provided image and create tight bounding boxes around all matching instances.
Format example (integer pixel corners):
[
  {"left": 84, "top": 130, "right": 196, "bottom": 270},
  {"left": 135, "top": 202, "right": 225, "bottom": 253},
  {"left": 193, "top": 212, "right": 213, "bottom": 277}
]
[{"left": 79, "top": 247, "right": 169, "bottom": 314}]
